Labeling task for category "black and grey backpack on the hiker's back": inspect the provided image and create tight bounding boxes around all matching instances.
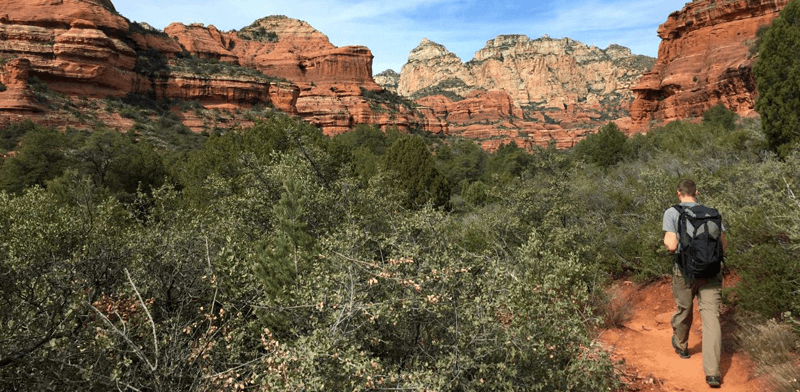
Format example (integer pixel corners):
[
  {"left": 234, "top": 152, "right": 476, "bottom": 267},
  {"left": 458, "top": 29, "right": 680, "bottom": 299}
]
[{"left": 674, "top": 204, "right": 725, "bottom": 279}]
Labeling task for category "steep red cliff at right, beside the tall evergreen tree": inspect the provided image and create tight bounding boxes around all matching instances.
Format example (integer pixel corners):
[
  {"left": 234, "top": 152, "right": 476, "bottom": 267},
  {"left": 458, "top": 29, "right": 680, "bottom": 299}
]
[{"left": 630, "top": 0, "right": 788, "bottom": 131}]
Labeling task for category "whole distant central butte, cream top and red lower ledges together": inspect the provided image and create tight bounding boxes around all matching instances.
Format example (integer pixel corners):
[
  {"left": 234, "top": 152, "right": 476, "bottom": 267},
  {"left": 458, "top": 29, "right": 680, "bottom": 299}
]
[{"left": 388, "top": 35, "right": 653, "bottom": 149}]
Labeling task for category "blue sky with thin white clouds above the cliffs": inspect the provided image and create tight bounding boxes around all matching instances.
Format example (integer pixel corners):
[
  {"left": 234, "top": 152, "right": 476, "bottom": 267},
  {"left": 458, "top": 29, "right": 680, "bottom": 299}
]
[{"left": 112, "top": 0, "right": 686, "bottom": 73}]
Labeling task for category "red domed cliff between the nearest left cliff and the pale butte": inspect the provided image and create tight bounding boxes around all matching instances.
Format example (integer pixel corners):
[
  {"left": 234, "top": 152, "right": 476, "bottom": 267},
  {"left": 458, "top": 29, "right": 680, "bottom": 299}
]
[{"left": 165, "top": 16, "right": 422, "bottom": 135}]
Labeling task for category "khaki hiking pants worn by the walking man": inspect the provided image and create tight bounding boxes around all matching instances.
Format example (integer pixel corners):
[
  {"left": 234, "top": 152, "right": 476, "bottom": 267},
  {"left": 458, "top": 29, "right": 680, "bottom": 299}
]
[{"left": 672, "top": 265, "right": 722, "bottom": 376}]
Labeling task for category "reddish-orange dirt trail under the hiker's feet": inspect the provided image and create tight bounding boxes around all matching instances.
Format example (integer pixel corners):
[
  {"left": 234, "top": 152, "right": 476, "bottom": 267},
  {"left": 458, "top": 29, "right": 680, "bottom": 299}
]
[{"left": 600, "top": 280, "right": 768, "bottom": 392}]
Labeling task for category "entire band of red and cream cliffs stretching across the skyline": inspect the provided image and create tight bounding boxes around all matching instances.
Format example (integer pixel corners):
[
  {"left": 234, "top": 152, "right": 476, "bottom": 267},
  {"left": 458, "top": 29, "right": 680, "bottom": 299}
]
[{"left": 12, "top": 0, "right": 776, "bottom": 150}]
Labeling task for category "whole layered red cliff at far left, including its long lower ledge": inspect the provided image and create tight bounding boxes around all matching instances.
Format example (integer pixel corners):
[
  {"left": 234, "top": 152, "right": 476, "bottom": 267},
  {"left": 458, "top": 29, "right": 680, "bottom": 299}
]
[{"left": 0, "top": 0, "right": 300, "bottom": 122}]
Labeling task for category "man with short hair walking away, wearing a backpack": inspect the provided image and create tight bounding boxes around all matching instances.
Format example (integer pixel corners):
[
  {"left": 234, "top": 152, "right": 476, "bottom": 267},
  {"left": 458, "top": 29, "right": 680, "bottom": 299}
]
[{"left": 663, "top": 180, "right": 728, "bottom": 388}]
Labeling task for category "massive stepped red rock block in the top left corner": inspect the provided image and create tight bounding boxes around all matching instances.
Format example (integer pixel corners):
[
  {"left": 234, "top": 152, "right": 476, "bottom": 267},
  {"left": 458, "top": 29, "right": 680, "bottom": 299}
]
[{"left": 0, "top": 0, "right": 145, "bottom": 96}]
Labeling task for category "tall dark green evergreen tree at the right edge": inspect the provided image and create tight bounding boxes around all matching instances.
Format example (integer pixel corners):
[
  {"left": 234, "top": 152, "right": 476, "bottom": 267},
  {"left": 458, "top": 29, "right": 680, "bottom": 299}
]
[{"left": 753, "top": 0, "right": 800, "bottom": 156}]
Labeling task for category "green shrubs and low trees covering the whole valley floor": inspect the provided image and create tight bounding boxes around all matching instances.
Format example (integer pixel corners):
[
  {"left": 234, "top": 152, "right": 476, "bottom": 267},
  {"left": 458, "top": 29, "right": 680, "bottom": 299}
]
[{"left": 0, "top": 98, "right": 800, "bottom": 391}]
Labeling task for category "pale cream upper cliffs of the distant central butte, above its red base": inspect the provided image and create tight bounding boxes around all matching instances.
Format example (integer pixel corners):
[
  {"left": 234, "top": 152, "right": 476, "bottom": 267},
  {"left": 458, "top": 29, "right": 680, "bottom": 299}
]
[{"left": 398, "top": 35, "right": 652, "bottom": 109}]
